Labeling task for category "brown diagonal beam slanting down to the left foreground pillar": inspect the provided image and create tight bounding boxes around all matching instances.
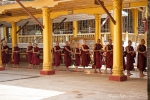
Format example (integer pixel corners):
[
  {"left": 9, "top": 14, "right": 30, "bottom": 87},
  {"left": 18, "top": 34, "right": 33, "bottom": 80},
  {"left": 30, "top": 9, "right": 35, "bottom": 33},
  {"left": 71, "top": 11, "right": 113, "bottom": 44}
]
[{"left": 16, "top": 0, "right": 44, "bottom": 29}]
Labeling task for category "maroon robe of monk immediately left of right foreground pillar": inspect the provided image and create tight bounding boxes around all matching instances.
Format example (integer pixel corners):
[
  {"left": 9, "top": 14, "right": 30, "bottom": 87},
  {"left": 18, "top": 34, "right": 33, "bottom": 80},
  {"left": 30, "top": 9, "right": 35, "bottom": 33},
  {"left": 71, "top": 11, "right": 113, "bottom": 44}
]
[{"left": 106, "top": 44, "right": 113, "bottom": 68}]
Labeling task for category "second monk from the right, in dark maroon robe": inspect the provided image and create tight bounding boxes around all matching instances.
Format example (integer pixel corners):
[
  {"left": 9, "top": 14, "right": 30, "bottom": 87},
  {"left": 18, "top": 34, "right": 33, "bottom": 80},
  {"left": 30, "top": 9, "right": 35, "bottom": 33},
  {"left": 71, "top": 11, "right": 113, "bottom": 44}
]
[{"left": 126, "top": 40, "right": 136, "bottom": 76}]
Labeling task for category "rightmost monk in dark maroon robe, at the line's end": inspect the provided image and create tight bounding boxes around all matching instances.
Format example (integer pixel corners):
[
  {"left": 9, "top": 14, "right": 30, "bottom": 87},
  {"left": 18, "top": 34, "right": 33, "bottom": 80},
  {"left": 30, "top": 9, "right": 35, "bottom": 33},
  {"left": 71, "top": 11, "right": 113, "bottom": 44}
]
[{"left": 137, "top": 39, "right": 147, "bottom": 77}]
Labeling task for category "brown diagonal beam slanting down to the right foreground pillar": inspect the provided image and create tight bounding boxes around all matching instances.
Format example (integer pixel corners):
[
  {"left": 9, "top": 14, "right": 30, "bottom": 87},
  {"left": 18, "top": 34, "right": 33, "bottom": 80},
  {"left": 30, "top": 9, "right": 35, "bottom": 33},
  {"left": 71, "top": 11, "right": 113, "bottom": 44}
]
[{"left": 95, "top": 0, "right": 116, "bottom": 25}]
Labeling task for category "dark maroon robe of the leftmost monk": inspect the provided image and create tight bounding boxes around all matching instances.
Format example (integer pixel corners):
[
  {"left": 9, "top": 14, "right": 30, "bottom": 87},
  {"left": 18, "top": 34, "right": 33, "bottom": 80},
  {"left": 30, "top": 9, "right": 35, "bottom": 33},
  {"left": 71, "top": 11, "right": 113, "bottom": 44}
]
[{"left": 2, "top": 45, "right": 9, "bottom": 64}]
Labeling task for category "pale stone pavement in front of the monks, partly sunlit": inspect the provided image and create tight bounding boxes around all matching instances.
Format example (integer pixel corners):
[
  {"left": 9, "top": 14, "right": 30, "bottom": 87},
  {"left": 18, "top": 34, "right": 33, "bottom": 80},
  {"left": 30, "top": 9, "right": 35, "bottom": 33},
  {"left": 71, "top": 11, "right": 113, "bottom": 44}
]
[{"left": 0, "top": 63, "right": 147, "bottom": 100}]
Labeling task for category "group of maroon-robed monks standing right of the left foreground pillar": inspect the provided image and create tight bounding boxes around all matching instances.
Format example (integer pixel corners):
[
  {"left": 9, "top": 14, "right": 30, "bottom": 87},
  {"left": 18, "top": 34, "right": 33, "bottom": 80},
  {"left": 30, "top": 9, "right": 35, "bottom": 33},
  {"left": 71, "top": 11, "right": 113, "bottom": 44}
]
[{"left": 53, "top": 39, "right": 146, "bottom": 77}]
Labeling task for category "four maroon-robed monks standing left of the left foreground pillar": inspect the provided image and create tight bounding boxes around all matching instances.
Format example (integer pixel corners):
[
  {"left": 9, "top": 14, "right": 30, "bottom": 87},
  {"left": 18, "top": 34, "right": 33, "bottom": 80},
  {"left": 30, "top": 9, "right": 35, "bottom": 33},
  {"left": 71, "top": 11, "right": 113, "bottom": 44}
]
[{"left": 2, "top": 41, "right": 40, "bottom": 69}]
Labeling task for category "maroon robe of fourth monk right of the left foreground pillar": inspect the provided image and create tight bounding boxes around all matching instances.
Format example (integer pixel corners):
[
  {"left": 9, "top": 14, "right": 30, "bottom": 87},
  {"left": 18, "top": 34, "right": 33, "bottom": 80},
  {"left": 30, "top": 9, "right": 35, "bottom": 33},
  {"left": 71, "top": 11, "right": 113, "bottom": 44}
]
[{"left": 81, "top": 45, "right": 91, "bottom": 67}]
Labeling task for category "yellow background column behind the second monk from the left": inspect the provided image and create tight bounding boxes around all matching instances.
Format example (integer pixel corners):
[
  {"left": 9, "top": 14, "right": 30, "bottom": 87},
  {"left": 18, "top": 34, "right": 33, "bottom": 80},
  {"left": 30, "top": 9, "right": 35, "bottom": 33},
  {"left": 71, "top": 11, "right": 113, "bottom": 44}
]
[{"left": 11, "top": 22, "right": 17, "bottom": 61}]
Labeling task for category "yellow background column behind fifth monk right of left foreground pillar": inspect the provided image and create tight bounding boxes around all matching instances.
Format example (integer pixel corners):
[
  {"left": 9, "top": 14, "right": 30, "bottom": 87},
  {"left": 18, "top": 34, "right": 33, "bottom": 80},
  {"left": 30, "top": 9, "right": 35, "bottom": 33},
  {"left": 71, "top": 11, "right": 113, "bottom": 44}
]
[{"left": 95, "top": 14, "right": 102, "bottom": 42}]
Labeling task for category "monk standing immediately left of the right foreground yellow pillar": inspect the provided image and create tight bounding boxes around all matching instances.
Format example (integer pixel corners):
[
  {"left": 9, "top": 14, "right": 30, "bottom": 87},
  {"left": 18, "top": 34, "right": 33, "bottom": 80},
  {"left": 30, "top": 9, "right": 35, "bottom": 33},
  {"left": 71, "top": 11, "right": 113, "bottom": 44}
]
[{"left": 104, "top": 39, "right": 113, "bottom": 74}]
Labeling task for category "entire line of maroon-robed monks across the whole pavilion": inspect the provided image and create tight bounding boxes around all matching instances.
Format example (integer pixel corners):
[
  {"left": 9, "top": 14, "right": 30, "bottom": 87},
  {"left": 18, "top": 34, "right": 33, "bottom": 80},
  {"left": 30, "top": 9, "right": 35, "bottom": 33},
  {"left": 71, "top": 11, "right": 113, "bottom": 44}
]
[{"left": 2, "top": 39, "right": 147, "bottom": 77}]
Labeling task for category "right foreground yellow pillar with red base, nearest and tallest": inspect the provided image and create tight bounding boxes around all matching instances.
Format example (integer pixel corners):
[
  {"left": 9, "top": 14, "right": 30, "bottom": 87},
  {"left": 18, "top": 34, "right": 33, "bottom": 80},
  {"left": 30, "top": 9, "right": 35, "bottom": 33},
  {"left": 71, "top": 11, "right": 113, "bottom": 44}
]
[{"left": 109, "top": 0, "right": 127, "bottom": 81}]
